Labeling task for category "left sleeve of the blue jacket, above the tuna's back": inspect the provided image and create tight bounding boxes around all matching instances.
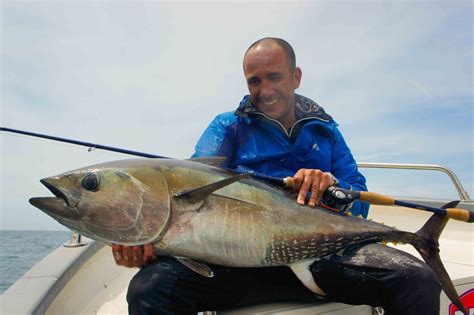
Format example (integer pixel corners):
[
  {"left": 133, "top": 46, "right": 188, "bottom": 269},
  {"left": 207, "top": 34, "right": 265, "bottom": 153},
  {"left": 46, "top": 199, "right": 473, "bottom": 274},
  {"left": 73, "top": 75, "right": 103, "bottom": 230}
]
[{"left": 192, "top": 112, "right": 236, "bottom": 167}]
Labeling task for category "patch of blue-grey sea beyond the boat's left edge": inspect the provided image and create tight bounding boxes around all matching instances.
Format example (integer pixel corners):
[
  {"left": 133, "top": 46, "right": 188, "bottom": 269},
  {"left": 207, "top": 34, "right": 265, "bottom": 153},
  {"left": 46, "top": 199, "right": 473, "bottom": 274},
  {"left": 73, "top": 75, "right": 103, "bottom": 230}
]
[{"left": 0, "top": 230, "right": 71, "bottom": 295}]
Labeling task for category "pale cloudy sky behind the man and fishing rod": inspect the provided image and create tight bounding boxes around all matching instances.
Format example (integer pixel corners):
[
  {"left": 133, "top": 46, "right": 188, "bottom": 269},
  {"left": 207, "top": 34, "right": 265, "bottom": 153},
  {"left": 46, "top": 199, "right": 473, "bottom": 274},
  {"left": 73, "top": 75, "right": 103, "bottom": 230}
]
[{"left": 0, "top": 0, "right": 474, "bottom": 230}]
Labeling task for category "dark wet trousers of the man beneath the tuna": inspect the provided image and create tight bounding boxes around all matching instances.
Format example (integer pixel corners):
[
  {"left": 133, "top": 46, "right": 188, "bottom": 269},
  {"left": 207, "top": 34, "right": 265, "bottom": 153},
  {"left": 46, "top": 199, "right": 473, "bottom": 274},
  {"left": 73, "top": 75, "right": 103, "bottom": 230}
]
[{"left": 127, "top": 244, "right": 441, "bottom": 315}]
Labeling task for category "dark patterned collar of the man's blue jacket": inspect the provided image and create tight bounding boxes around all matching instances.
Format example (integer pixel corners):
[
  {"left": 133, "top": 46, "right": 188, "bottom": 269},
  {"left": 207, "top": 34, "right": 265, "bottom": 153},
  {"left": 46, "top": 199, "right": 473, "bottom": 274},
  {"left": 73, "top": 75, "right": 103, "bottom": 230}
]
[{"left": 235, "top": 94, "right": 334, "bottom": 122}]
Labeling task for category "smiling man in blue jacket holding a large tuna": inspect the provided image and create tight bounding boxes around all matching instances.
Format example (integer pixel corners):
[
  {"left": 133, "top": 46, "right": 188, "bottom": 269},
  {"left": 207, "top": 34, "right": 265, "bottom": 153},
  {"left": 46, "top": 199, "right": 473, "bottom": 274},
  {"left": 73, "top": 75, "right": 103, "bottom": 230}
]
[{"left": 113, "top": 38, "right": 441, "bottom": 314}]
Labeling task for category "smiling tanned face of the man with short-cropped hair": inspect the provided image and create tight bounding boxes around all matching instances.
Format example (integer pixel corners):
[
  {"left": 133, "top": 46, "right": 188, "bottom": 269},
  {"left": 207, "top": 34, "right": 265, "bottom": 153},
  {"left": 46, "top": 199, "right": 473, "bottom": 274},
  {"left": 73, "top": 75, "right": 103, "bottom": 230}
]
[{"left": 244, "top": 45, "right": 301, "bottom": 128}]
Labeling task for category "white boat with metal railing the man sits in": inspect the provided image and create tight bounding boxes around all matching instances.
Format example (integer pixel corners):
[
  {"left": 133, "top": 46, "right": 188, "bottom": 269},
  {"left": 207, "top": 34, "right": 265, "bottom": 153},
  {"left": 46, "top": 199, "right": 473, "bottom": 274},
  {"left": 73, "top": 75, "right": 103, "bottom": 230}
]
[{"left": 1, "top": 163, "right": 474, "bottom": 315}]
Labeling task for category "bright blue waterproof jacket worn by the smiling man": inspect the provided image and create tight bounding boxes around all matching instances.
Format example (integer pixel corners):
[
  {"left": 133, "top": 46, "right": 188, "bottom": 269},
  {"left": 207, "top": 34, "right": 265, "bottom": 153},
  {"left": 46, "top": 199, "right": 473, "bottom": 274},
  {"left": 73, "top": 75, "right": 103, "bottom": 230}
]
[{"left": 193, "top": 94, "right": 369, "bottom": 217}]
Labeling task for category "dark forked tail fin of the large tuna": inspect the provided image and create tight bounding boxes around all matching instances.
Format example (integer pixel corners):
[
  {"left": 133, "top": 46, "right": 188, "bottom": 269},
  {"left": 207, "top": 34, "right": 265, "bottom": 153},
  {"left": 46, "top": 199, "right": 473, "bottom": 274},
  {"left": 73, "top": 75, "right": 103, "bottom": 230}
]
[{"left": 411, "top": 201, "right": 467, "bottom": 314}]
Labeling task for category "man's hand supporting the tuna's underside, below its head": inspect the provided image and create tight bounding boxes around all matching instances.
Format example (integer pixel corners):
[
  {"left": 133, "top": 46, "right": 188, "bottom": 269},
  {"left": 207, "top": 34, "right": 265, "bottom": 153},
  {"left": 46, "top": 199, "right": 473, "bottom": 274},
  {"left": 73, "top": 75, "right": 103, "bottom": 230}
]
[{"left": 112, "top": 243, "right": 156, "bottom": 268}]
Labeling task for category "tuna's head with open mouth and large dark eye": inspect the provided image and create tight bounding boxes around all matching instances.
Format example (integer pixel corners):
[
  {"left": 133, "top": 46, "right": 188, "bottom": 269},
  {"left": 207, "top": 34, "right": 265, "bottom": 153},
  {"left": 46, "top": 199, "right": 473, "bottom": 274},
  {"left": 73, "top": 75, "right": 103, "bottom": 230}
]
[{"left": 30, "top": 167, "right": 170, "bottom": 245}]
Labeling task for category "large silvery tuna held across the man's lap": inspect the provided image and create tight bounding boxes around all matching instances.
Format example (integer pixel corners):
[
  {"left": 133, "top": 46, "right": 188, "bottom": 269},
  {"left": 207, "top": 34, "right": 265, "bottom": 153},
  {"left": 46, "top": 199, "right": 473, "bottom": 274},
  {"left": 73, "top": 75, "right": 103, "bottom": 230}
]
[{"left": 30, "top": 158, "right": 465, "bottom": 311}]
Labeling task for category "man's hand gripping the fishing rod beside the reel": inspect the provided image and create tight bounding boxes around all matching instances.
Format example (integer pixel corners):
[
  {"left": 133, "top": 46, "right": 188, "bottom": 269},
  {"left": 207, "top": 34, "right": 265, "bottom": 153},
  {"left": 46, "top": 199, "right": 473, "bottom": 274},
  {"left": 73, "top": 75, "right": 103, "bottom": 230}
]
[{"left": 293, "top": 168, "right": 335, "bottom": 207}]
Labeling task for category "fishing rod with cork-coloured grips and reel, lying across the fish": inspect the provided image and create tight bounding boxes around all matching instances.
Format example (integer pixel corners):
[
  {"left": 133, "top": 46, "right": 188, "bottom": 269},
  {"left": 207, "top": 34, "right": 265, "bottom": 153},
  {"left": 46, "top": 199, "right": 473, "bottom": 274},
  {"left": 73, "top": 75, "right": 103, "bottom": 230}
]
[{"left": 0, "top": 127, "right": 474, "bottom": 222}]
